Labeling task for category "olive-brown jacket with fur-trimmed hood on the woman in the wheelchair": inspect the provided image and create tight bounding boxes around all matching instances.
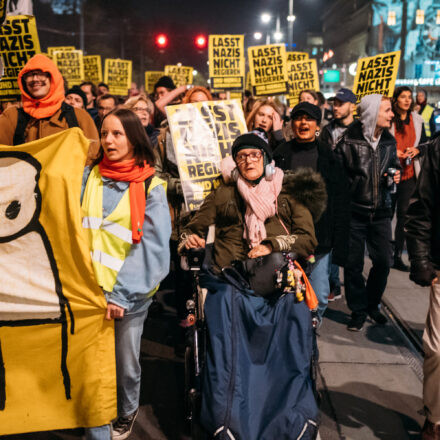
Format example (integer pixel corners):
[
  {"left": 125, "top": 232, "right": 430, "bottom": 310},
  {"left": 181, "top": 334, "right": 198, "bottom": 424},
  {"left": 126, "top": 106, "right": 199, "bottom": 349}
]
[{"left": 181, "top": 170, "right": 326, "bottom": 270}]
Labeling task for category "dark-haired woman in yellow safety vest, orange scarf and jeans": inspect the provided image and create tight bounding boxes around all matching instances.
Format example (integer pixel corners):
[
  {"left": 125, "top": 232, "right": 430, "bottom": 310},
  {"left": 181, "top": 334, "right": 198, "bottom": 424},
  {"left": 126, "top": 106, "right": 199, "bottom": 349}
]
[{"left": 81, "top": 108, "right": 171, "bottom": 440}]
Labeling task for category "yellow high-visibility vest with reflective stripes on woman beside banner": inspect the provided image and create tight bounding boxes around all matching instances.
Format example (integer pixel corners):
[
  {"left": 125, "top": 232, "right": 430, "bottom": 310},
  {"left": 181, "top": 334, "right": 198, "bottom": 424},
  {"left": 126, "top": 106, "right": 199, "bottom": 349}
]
[{"left": 81, "top": 166, "right": 166, "bottom": 296}]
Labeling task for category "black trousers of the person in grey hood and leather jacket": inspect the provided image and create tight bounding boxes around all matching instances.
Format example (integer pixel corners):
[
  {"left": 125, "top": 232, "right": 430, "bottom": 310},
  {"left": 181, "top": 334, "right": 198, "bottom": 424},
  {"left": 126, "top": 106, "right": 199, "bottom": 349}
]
[{"left": 344, "top": 214, "right": 392, "bottom": 316}]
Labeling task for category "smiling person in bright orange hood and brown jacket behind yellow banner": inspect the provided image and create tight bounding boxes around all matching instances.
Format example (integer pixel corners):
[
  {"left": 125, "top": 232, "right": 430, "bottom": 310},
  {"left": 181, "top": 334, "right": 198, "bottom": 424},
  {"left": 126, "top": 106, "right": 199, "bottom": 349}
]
[{"left": 0, "top": 54, "right": 99, "bottom": 163}]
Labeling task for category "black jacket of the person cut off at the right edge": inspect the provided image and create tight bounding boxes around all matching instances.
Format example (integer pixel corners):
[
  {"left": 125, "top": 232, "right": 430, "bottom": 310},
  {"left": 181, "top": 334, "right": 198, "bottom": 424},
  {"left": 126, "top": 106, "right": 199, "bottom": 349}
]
[{"left": 405, "top": 135, "right": 440, "bottom": 285}]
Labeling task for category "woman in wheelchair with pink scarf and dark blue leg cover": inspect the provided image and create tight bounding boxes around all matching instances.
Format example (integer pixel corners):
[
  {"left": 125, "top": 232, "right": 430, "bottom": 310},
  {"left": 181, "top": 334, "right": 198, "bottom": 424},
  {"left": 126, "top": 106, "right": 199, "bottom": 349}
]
[{"left": 179, "top": 130, "right": 326, "bottom": 440}]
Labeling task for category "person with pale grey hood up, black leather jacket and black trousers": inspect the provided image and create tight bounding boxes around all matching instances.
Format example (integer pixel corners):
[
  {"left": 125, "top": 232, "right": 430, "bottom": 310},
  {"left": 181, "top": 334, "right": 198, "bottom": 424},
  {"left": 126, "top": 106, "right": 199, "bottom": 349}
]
[{"left": 336, "top": 94, "right": 401, "bottom": 331}]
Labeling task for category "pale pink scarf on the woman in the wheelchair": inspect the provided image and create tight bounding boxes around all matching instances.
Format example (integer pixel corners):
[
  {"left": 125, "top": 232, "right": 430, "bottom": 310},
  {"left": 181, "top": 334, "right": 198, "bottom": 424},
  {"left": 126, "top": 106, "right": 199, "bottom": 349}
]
[{"left": 220, "top": 156, "right": 284, "bottom": 248}]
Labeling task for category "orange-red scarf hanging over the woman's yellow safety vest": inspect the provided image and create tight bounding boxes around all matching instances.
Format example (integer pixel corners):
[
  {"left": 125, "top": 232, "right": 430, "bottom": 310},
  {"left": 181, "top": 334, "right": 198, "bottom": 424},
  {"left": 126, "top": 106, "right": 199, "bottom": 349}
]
[{"left": 99, "top": 155, "right": 154, "bottom": 243}]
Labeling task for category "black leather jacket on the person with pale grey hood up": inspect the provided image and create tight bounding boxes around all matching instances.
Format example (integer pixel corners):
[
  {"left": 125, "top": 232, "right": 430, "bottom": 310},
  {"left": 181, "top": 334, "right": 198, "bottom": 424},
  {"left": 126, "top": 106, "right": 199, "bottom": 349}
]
[{"left": 335, "top": 121, "right": 400, "bottom": 218}]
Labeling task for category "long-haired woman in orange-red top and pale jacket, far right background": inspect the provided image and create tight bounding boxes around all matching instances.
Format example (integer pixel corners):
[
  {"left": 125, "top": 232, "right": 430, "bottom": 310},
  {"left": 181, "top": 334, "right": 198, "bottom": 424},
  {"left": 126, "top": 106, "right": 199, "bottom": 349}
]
[{"left": 390, "top": 86, "right": 426, "bottom": 272}]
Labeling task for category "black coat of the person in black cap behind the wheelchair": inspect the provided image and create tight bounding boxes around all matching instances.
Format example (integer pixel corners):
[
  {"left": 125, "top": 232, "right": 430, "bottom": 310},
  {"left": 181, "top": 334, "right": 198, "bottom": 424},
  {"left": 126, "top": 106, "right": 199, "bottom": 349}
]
[{"left": 274, "top": 139, "right": 350, "bottom": 266}]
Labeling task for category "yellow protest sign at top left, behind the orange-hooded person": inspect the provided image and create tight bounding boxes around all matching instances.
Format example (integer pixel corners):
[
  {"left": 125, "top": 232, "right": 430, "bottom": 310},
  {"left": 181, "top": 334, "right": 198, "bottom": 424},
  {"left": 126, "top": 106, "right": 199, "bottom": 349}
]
[{"left": 0, "top": 15, "right": 41, "bottom": 101}]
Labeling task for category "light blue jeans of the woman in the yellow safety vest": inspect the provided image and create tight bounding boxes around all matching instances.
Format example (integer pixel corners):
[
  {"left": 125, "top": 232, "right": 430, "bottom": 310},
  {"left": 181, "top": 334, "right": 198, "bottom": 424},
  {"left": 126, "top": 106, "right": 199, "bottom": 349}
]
[{"left": 85, "top": 298, "right": 152, "bottom": 440}]
